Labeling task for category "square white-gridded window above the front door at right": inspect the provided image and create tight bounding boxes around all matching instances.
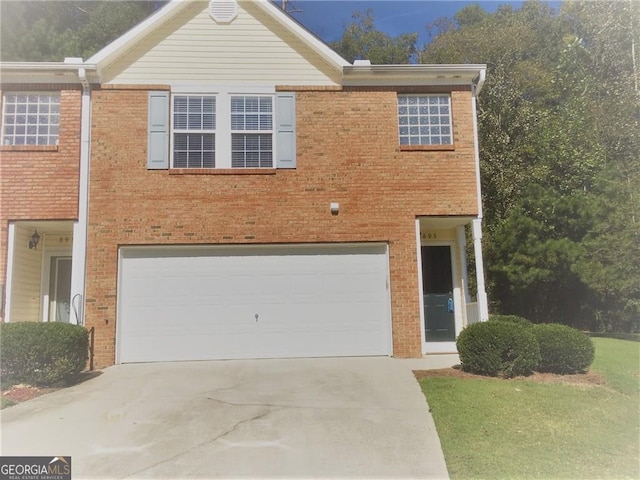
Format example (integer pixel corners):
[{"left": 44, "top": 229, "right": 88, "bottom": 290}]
[{"left": 398, "top": 95, "right": 453, "bottom": 145}]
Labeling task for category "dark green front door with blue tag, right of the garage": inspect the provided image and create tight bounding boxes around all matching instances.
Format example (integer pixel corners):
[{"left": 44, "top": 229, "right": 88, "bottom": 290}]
[{"left": 422, "top": 245, "right": 456, "bottom": 342}]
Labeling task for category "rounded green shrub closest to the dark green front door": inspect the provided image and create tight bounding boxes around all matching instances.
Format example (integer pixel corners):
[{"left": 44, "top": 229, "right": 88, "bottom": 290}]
[{"left": 456, "top": 321, "right": 540, "bottom": 378}]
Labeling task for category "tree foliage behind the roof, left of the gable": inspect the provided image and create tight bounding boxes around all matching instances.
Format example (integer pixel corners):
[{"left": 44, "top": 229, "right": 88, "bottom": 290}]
[{"left": 0, "top": 0, "right": 166, "bottom": 62}]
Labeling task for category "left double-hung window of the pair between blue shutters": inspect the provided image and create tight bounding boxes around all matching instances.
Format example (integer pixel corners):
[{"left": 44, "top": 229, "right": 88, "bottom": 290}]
[{"left": 173, "top": 95, "right": 216, "bottom": 168}]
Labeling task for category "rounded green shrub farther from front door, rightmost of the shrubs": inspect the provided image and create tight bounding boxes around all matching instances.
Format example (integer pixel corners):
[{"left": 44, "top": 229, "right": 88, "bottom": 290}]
[{"left": 533, "top": 323, "right": 595, "bottom": 374}]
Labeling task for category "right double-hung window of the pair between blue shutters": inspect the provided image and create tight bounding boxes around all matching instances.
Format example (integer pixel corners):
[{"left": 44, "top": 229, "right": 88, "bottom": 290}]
[{"left": 231, "top": 95, "right": 273, "bottom": 168}]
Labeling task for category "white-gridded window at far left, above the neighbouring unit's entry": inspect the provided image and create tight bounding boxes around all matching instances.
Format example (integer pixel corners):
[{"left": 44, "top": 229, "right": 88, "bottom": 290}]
[{"left": 2, "top": 92, "right": 60, "bottom": 145}]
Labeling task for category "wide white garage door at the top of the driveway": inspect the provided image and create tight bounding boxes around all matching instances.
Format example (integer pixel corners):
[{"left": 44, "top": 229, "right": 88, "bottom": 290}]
[{"left": 117, "top": 244, "right": 391, "bottom": 363}]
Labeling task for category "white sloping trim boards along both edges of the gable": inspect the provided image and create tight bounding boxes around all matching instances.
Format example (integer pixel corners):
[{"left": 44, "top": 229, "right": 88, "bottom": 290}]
[{"left": 86, "top": 0, "right": 351, "bottom": 73}]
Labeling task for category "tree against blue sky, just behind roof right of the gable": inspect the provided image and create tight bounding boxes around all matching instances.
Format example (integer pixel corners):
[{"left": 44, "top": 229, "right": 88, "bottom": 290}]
[{"left": 330, "top": 10, "right": 418, "bottom": 65}]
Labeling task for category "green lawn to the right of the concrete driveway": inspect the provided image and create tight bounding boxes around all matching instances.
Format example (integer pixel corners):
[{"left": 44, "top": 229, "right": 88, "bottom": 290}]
[{"left": 420, "top": 338, "right": 640, "bottom": 480}]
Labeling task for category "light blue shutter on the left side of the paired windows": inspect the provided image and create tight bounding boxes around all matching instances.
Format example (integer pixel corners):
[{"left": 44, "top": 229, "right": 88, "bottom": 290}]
[{"left": 147, "top": 92, "right": 169, "bottom": 170}]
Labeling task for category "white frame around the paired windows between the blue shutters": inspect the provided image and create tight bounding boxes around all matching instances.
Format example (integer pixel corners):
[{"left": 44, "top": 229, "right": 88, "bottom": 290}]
[{"left": 169, "top": 89, "right": 277, "bottom": 170}]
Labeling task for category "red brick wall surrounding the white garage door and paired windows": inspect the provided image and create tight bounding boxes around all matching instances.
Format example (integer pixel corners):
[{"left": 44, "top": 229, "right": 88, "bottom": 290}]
[{"left": 86, "top": 89, "right": 478, "bottom": 366}]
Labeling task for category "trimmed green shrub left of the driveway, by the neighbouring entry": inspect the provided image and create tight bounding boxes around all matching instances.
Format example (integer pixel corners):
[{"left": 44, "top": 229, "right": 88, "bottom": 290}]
[{"left": 0, "top": 322, "right": 89, "bottom": 386}]
